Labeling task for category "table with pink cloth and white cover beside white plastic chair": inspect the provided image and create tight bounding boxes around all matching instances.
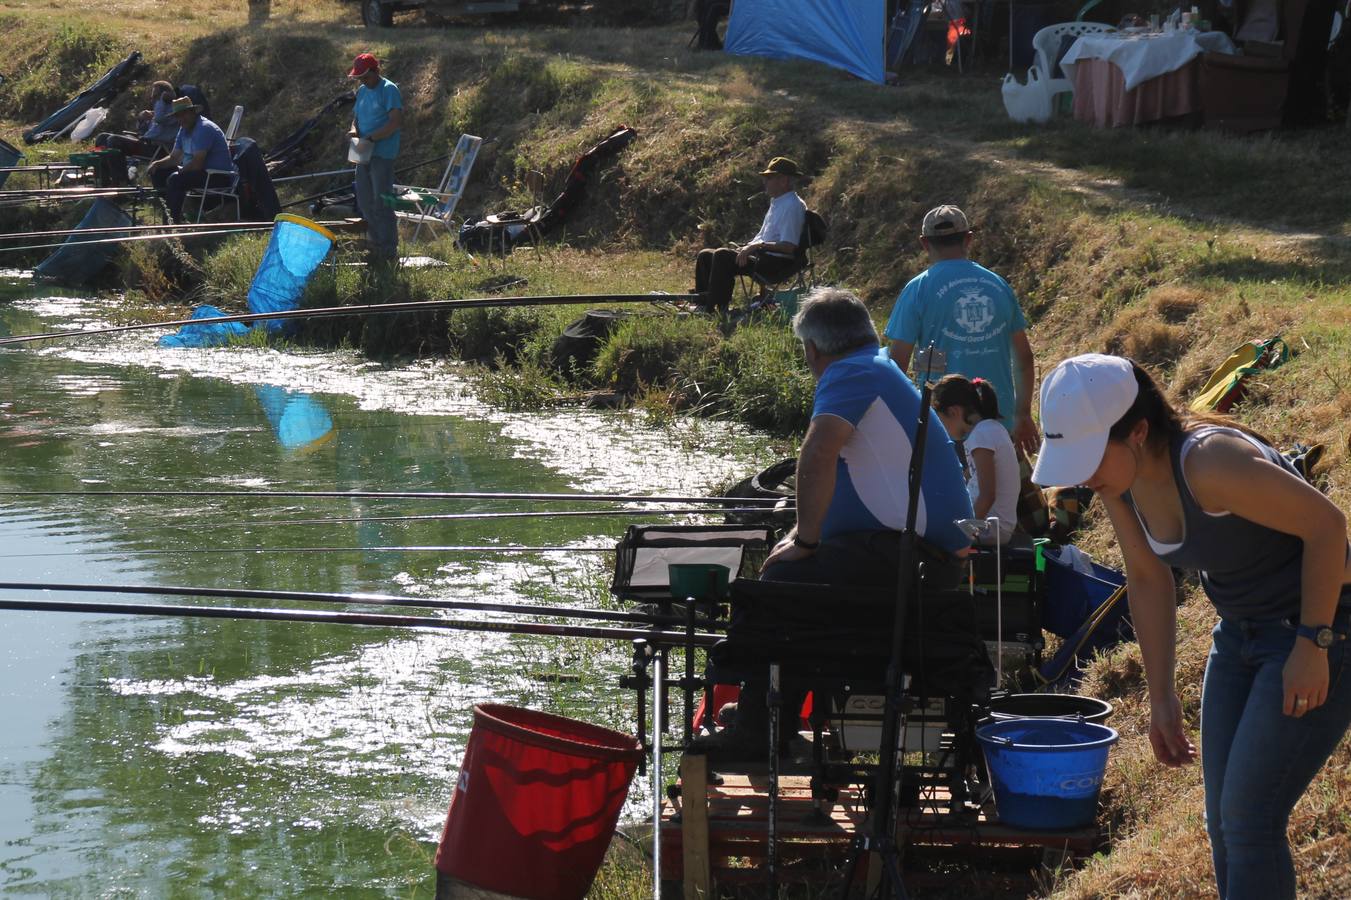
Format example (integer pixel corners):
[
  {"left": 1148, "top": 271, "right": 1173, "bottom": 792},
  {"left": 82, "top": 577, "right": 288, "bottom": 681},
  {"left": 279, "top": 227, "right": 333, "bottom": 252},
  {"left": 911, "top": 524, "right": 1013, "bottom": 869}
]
[{"left": 1061, "top": 31, "right": 1233, "bottom": 127}]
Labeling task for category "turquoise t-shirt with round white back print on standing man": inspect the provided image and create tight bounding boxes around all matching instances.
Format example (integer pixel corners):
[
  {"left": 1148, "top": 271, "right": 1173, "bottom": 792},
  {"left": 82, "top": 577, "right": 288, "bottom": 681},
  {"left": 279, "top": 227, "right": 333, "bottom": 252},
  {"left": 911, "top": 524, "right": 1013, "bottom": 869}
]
[{"left": 886, "top": 259, "right": 1027, "bottom": 428}]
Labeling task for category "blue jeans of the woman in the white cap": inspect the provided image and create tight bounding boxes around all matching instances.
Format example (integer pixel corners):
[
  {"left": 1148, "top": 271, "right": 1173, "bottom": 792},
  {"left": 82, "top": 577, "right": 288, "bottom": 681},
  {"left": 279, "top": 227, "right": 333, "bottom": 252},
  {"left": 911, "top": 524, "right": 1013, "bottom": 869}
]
[{"left": 1201, "top": 608, "right": 1351, "bottom": 900}]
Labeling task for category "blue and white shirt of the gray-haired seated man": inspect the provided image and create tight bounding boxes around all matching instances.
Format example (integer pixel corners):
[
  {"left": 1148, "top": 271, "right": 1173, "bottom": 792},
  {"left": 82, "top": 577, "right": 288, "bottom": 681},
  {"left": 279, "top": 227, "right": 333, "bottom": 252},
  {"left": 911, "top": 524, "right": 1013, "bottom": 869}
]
[{"left": 812, "top": 347, "right": 973, "bottom": 551}]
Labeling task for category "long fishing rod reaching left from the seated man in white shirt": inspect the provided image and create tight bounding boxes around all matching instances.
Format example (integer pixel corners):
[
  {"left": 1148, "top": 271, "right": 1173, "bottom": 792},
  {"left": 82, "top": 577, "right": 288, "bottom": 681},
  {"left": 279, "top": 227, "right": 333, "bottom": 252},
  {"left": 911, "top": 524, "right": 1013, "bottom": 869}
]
[{"left": 0, "top": 293, "right": 701, "bottom": 346}]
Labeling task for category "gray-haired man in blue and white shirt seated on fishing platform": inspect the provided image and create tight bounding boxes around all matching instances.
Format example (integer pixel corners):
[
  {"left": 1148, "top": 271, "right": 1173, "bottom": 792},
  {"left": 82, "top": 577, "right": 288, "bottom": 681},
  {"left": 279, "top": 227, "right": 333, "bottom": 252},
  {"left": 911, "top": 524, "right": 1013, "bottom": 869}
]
[{"left": 698, "top": 288, "right": 971, "bottom": 758}]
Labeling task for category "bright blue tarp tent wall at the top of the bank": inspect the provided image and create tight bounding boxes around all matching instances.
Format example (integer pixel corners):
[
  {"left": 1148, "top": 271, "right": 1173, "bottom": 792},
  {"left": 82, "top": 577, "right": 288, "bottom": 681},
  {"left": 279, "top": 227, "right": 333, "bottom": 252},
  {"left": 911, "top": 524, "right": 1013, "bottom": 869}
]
[{"left": 723, "top": 0, "right": 886, "bottom": 84}]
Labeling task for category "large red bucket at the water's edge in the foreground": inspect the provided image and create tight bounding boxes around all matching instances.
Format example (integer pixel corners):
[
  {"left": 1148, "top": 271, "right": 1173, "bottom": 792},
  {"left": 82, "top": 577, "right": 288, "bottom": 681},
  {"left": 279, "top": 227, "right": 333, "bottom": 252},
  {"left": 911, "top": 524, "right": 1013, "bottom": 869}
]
[{"left": 436, "top": 704, "right": 643, "bottom": 900}]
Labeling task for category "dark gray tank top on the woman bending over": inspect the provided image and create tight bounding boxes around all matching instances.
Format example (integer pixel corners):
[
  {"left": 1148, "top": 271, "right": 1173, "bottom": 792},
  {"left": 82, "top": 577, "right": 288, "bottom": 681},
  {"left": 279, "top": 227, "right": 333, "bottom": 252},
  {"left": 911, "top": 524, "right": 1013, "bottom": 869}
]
[{"left": 1123, "top": 426, "right": 1351, "bottom": 619}]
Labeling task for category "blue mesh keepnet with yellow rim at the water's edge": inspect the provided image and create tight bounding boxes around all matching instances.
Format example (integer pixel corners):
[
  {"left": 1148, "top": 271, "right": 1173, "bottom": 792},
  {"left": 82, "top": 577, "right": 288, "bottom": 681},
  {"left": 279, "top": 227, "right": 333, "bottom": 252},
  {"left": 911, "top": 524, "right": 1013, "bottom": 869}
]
[{"left": 159, "top": 215, "right": 334, "bottom": 347}]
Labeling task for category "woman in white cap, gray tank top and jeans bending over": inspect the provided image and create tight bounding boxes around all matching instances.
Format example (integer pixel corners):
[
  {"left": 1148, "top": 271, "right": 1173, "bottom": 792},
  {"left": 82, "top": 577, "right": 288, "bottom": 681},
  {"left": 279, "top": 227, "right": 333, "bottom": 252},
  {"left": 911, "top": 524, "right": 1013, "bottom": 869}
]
[{"left": 1032, "top": 354, "right": 1351, "bottom": 900}]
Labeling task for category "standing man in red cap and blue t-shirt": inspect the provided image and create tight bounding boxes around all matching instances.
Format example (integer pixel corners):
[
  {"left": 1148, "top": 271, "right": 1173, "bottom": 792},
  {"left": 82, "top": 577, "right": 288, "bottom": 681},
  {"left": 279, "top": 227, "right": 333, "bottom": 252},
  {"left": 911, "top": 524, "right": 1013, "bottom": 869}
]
[{"left": 347, "top": 53, "right": 404, "bottom": 262}]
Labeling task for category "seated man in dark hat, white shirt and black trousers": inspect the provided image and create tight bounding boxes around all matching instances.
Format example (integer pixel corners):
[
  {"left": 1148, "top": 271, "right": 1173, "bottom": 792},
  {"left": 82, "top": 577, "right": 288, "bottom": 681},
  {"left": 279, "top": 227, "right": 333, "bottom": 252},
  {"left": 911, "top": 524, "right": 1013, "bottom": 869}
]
[{"left": 694, "top": 157, "right": 807, "bottom": 312}]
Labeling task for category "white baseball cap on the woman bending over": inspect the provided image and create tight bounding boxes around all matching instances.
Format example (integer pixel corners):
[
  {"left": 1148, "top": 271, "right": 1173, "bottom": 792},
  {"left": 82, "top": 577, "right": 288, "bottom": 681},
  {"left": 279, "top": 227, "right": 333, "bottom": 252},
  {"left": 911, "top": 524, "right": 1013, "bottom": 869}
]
[{"left": 1032, "top": 353, "right": 1140, "bottom": 486}]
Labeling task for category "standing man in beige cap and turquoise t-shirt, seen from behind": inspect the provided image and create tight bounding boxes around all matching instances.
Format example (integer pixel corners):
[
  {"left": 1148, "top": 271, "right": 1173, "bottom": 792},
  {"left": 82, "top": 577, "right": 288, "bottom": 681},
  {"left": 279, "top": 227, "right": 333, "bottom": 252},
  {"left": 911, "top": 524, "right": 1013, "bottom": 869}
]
[{"left": 886, "top": 205, "right": 1039, "bottom": 453}]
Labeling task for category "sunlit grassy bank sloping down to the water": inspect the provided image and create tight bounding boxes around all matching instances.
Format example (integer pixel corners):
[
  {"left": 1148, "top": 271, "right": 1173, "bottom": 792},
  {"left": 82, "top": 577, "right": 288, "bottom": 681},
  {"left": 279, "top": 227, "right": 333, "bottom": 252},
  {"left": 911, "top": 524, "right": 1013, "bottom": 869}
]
[{"left": 0, "top": 0, "right": 1351, "bottom": 897}]
